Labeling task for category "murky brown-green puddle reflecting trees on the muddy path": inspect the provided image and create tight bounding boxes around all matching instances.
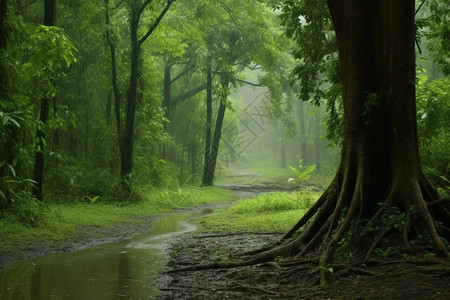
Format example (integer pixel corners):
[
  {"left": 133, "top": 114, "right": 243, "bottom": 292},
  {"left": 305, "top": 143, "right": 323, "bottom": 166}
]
[{"left": 0, "top": 213, "right": 196, "bottom": 300}]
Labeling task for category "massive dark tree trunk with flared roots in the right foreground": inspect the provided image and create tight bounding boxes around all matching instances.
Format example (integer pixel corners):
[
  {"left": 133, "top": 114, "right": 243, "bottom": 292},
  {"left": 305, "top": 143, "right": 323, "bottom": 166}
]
[{"left": 248, "top": 0, "right": 450, "bottom": 267}]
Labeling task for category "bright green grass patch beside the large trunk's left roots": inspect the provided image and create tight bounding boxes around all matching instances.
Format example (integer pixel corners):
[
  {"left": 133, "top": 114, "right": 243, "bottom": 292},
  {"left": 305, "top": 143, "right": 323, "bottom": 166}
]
[{"left": 199, "top": 190, "right": 320, "bottom": 232}]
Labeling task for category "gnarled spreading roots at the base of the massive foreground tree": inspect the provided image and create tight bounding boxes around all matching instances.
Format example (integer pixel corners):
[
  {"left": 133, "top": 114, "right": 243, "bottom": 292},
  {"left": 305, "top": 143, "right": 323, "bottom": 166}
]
[{"left": 168, "top": 170, "right": 450, "bottom": 283}]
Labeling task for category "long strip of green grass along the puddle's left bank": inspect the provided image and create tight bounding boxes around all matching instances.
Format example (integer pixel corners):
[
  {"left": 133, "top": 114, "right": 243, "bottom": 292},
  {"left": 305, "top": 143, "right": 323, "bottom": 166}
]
[{"left": 0, "top": 187, "right": 234, "bottom": 252}]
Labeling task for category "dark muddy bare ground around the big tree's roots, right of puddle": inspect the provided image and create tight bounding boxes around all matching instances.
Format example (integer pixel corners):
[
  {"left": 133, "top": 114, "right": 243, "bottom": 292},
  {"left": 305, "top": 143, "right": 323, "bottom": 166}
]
[{"left": 156, "top": 233, "right": 450, "bottom": 300}]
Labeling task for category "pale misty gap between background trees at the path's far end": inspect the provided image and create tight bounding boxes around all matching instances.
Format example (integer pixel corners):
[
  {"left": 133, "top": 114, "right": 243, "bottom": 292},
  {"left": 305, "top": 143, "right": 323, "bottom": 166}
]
[{"left": 213, "top": 76, "right": 339, "bottom": 183}]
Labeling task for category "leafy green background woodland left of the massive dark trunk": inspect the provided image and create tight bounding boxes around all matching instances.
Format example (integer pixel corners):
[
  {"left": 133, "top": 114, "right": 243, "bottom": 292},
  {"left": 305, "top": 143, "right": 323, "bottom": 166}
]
[{"left": 1, "top": 1, "right": 334, "bottom": 216}]
